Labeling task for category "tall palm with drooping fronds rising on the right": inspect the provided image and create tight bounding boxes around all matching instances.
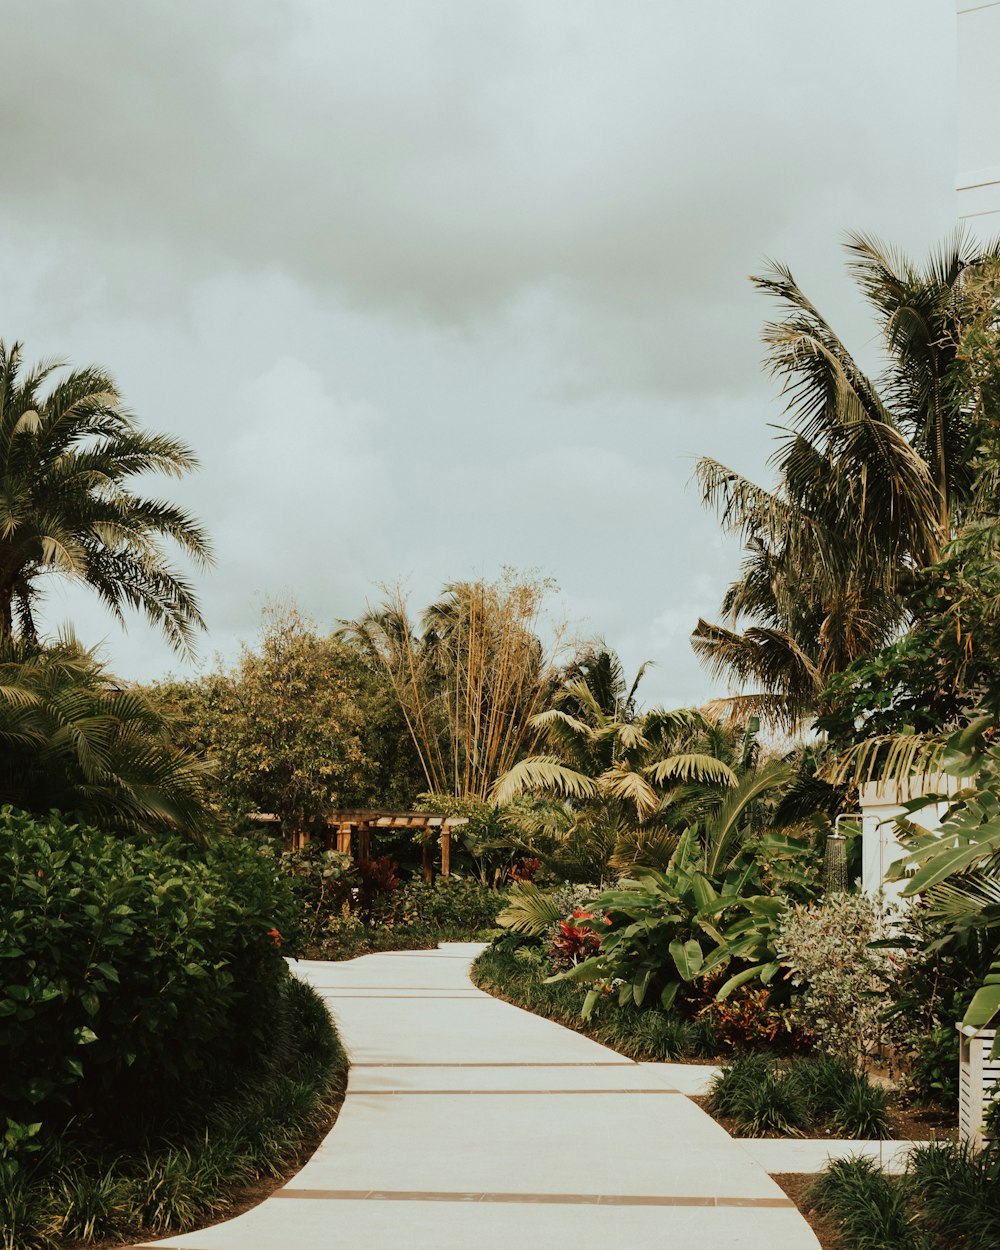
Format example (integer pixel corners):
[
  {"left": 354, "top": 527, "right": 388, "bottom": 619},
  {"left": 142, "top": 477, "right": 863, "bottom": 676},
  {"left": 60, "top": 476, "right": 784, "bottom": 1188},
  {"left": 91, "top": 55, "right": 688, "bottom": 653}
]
[{"left": 693, "top": 231, "right": 1000, "bottom": 729}]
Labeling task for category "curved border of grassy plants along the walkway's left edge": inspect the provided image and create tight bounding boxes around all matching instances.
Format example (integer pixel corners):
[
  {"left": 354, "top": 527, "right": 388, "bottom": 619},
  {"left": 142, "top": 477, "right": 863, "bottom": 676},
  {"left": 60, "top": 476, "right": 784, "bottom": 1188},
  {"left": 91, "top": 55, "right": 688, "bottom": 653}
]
[{"left": 0, "top": 979, "right": 348, "bottom": 1250}]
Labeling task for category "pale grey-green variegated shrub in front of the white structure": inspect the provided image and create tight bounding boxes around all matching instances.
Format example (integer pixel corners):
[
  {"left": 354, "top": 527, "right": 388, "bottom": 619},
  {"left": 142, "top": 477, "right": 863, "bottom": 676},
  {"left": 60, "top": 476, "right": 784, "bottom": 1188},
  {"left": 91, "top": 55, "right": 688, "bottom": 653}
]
[{"left": 778, "top": 894, "right": 900, "bottom": 1066}]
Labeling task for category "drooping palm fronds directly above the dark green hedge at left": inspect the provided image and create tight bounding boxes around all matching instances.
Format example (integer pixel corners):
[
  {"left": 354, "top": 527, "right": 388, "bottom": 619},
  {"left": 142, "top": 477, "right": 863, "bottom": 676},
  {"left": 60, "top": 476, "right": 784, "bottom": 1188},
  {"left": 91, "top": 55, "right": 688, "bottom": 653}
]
[{"left": 0, "top": 635, "right": 215, "bottom": 839}]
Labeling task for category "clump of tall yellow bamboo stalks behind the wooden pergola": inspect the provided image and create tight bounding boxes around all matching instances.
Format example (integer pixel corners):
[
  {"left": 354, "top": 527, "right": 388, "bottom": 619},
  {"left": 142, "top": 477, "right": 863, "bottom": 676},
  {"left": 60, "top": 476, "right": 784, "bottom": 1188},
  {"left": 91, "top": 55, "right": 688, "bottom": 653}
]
[{"left": 345, "top": 573, "right": 560, "bottom": 800}]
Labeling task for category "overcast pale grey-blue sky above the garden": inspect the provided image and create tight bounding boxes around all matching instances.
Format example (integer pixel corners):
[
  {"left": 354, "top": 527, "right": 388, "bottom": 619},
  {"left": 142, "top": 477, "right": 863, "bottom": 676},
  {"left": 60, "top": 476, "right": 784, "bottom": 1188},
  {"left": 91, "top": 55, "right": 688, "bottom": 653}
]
[{"left": 0, "top": 0, "right": 955, "bottom": 705}]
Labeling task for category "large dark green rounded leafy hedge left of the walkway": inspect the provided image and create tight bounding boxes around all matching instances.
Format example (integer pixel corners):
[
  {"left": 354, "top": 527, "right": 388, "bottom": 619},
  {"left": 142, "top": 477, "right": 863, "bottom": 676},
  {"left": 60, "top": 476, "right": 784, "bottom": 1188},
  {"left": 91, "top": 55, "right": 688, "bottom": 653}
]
[{"left": 0, "top": 808, "right": 295, "bottom": 1145}]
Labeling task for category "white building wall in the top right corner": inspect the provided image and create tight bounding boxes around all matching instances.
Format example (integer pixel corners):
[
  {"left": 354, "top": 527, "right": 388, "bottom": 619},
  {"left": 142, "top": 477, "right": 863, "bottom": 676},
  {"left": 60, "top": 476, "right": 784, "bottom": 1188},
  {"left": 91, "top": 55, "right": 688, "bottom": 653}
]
[{"left": 958, "top": 0, "right": 1000, "bottom": 226}]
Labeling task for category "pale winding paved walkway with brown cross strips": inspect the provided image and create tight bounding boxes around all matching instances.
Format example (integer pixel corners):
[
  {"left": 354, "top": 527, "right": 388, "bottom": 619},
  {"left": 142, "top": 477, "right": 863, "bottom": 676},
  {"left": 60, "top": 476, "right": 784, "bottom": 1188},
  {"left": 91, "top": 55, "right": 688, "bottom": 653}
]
[{"left": 140, "top": 945, "right": 819, "bottom": 1250}]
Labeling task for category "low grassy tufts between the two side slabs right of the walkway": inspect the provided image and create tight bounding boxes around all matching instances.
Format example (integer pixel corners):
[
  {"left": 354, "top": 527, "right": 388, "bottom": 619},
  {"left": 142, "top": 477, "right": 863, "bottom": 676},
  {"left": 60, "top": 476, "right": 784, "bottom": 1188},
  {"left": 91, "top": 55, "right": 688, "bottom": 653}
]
[{"left": 708, "top": 1054, "right": 890, "bottom": 1140}]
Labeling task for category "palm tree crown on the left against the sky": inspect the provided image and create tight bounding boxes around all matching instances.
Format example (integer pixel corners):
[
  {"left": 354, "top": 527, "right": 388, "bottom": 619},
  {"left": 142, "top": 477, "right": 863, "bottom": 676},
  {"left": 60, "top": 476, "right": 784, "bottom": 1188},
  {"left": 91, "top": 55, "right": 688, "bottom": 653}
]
[{"left": 0, "top": 341, "right": 210, "bottom": 650}]
